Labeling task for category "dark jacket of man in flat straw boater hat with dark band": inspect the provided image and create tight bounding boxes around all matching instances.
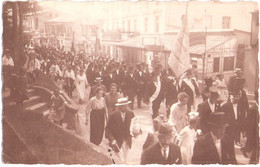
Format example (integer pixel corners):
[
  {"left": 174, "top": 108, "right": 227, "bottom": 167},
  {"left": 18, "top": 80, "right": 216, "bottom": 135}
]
[{"left": 105, "top": 111, "right": 135, "bottom": 148}]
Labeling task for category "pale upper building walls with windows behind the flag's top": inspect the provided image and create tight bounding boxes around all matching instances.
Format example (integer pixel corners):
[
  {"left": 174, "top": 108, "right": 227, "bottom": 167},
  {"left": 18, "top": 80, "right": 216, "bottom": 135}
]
[{"left": 104, "top": 1, "right": 258, "bottom": 34}]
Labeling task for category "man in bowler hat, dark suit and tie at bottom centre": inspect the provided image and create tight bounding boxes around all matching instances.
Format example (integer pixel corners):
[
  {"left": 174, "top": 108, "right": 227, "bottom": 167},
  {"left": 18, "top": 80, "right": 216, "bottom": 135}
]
[{"left": 141, "top": 123, "right": 182, "bottom": 165}]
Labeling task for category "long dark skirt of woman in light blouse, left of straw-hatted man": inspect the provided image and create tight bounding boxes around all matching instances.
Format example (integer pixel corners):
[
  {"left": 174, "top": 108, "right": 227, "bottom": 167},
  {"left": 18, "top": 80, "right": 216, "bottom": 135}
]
[{"left": 90, "top": 109, "right": 105, "bottom": 145}]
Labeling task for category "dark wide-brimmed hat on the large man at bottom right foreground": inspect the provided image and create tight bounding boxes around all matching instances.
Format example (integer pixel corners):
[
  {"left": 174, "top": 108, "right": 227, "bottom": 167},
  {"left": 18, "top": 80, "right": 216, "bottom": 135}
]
[{"left": 208, "top": 112, "right": 228, "bottom": 128}]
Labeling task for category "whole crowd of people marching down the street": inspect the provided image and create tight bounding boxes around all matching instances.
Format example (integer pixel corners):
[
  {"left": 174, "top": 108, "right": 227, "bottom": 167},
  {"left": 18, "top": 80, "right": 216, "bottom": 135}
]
[{"left": 3, "top": 42, "right": 259, "bottom": 164}]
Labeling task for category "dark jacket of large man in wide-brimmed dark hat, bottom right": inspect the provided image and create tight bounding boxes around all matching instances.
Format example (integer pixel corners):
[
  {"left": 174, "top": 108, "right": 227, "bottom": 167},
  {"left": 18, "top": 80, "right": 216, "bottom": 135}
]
[{"left": 192, "top": 133, "right": 236, "bottom": 164}]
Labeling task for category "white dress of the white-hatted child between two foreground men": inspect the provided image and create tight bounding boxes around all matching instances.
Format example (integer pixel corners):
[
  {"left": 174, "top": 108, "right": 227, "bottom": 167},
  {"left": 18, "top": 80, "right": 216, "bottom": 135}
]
[{"left": 177, "top": 126, "right": 196, "bottom": 165}]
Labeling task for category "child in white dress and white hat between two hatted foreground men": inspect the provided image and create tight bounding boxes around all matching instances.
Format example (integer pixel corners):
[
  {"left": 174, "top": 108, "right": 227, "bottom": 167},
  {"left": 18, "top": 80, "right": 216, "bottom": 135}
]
[{"left": 177, "top": 112, "right": 199, "bottom": 165}]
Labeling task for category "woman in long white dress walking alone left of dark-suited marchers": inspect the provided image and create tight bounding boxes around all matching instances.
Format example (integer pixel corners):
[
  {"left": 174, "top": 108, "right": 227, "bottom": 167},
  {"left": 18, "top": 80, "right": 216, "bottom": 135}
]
[{"left": 75, "top": 69, "right": 88, "bottom": 104}]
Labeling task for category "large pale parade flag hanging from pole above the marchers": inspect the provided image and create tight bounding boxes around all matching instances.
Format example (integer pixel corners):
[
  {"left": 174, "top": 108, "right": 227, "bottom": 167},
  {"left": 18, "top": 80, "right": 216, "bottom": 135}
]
[{"left": 168, "top": 12, "right": 190, "bottom": 77}]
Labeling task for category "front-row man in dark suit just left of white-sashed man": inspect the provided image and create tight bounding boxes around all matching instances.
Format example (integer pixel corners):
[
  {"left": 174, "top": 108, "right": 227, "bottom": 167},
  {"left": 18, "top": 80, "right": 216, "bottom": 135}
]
[{"left": 134, "top": 64, "right": 145, "bottom": 108}]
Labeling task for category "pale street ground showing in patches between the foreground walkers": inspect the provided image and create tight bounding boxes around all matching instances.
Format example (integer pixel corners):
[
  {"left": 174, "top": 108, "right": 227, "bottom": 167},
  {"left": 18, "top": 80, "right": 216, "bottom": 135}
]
[{"left": 68, "top": 87, "right": 249, "bottom": 165}]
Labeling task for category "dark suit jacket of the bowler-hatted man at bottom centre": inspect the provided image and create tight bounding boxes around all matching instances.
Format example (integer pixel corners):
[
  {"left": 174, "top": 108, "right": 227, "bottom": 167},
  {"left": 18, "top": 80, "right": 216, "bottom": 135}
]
[{"left": 141, "top": 142, "right": 182, "bottom": 165}]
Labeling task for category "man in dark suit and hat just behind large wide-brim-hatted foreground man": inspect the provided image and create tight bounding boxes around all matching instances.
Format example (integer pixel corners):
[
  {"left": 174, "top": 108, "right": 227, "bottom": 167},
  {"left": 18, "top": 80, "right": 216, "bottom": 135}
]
[{"left": 197, "top": 87, "right": 219, "bottom": 134}]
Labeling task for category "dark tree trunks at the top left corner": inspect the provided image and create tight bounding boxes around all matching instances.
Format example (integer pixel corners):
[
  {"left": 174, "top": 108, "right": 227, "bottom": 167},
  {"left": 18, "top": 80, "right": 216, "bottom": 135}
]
[{"left": 2, "top": 1, "right": 40, "bottom": 69}]
